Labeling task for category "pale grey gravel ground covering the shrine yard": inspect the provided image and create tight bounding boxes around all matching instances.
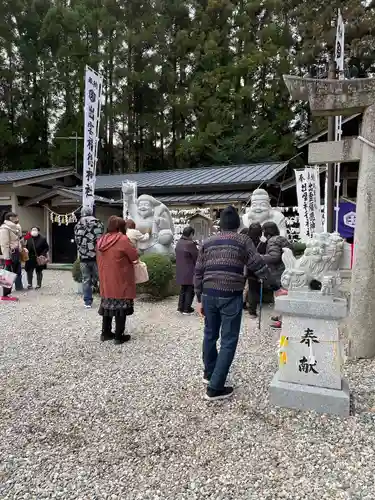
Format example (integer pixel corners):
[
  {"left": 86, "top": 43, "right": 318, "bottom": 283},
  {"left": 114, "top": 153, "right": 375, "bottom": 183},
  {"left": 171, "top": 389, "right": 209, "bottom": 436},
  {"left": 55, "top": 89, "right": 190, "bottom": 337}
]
[{"left": 0, "top": 271, "right": 375, "bottom": 500}]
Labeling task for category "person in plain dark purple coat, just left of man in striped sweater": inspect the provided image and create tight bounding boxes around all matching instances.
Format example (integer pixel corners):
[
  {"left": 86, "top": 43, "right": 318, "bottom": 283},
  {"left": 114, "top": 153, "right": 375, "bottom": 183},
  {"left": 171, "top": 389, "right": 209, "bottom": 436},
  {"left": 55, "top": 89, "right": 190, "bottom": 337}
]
[{"left": 175, "top": 226, "right": 198, "bottom": 314}]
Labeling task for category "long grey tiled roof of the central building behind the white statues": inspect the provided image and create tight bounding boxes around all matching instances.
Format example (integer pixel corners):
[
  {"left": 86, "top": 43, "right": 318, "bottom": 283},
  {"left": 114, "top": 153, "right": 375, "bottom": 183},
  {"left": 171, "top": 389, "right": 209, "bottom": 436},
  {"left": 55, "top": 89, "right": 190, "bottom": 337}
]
[{"left": 96, "top": 162, "right": 288, "bottom": 191}]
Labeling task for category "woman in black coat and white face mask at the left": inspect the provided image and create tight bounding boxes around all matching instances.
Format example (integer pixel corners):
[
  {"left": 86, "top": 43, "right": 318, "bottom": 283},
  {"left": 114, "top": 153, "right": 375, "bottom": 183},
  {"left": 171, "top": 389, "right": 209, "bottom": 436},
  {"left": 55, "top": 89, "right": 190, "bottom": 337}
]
[{"left": 25, "top": 227, "right": 49, "bottom": 290}]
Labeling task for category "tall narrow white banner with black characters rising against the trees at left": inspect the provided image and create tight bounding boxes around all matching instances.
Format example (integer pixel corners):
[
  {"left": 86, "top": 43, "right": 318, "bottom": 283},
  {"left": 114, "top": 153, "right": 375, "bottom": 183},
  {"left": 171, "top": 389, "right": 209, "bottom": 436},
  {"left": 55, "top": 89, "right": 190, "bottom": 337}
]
[{"left": 82, "top": 66, "right": 103, "bottom": 209}]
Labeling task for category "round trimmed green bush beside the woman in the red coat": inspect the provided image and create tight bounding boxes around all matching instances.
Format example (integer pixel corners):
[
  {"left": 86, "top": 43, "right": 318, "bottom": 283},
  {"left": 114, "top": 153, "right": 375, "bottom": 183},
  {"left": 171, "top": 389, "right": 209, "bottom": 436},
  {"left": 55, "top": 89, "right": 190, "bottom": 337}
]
[{"left": 138, "top": 253, "right": 174, "bottom": 299}]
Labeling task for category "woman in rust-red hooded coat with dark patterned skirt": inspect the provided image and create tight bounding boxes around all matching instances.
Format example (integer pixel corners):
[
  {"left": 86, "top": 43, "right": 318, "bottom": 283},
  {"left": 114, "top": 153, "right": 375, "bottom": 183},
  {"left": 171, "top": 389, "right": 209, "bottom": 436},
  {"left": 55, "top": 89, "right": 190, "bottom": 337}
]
[{"left": 97, "top": 215, "right": 138, "bottom": 344}]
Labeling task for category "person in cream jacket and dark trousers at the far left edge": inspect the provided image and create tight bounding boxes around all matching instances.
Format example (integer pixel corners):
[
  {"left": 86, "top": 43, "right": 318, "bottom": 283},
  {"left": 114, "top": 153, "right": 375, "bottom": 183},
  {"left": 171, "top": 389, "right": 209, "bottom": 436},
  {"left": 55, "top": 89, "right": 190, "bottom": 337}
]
[{"left": 0, "top": 212, "right": 23, "bottom": 301}]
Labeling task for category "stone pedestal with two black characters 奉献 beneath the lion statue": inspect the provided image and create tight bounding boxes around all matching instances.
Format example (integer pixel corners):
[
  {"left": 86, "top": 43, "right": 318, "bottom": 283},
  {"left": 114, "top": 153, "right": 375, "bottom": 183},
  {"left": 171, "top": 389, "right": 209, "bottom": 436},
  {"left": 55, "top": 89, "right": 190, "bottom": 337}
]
[{"left": 270, "top": 291, "right": 350, "bottom": 416}]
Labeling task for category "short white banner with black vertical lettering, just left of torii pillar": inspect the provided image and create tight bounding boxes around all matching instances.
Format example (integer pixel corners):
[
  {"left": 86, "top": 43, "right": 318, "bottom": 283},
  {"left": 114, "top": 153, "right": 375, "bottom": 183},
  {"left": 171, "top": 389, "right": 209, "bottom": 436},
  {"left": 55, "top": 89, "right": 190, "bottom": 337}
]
[{"left": 294, "top": 167, "right": 323, "bottom": 240}]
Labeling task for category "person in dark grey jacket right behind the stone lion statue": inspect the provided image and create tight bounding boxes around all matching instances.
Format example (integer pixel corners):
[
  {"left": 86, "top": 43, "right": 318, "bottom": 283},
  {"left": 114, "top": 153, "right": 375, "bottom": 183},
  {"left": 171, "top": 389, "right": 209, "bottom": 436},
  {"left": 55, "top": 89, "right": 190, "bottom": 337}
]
[{"left": 262, "top": 222, "right": 292, "bottom": 329}]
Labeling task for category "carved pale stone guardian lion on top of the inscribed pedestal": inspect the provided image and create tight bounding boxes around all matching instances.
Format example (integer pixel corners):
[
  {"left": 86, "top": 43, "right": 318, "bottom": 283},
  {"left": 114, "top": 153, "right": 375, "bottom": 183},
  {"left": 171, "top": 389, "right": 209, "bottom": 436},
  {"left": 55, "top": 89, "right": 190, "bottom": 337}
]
[{"left": 281, "top": 233, "right": 344, "bottom": 295}]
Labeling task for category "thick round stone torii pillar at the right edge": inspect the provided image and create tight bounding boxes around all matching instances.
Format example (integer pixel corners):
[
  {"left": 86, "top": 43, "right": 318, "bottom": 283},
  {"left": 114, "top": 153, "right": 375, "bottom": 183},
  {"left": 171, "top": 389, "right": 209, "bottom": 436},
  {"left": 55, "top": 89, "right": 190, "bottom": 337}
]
[{"left": 349, "top": 105, "right": 375, "bottom": 358}]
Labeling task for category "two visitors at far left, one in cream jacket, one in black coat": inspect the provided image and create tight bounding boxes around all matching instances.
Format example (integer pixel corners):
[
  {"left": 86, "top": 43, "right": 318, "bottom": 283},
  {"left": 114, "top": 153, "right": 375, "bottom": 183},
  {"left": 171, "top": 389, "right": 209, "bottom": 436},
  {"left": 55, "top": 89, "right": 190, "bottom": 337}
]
[{"left": 0, "top": 212, "right": 49, "bottom": 301}]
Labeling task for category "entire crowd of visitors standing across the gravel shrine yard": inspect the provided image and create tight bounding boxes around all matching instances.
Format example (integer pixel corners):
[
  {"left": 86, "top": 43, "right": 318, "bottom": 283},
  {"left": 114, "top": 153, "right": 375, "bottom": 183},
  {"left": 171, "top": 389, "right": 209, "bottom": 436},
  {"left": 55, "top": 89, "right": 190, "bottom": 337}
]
[{"left": 0, "top": 206, "right": 289, "bottom": 401}]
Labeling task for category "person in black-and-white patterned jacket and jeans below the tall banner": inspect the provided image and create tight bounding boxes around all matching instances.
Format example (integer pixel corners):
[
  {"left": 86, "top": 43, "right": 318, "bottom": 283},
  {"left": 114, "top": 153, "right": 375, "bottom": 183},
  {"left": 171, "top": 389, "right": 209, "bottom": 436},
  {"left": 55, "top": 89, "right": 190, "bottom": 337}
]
[{"left": 74, "top": 207, "right": 104, "bottom": 309}]
